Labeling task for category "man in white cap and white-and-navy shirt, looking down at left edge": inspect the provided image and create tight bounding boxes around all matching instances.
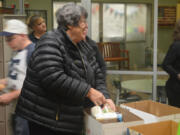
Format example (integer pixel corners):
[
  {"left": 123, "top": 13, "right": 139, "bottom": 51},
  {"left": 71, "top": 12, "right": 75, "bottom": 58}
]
[{"left": 0, "top": 19, "right": 34, "bottom": 135}]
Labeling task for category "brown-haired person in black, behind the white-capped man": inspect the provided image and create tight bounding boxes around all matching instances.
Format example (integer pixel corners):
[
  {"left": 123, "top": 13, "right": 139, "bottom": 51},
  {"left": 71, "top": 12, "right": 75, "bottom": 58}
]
[{"left": 27, "top": 15, "right": 46, "bottom": 43}]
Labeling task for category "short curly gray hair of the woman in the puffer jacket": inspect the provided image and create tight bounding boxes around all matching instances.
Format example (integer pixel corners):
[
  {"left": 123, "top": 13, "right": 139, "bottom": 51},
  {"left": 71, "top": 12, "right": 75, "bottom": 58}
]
[{"left": 56, "top": 3, "right": 88, "bottom": 30}]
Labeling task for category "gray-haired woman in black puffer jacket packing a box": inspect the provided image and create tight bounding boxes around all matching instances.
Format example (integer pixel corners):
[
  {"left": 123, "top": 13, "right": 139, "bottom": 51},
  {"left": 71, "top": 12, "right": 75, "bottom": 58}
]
[{"left": 16, "top": 3, "right": 115, "bottom": 135}]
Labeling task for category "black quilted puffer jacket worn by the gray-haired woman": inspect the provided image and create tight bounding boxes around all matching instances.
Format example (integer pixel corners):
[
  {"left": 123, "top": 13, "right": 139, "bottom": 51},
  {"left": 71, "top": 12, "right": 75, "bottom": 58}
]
[{"left": 16, "top": 29, "right": 109, "bottom": 133}]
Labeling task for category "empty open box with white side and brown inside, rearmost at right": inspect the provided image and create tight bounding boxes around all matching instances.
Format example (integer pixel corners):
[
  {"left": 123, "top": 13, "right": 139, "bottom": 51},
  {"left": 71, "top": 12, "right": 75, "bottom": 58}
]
[{"left": 120, "top": 100, "right": 180, "bottom": 123}]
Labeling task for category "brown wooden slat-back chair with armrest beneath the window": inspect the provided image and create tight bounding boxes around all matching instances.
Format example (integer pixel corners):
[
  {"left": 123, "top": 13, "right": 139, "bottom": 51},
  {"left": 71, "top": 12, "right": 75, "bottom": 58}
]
[{"left": 97, "top": 42, "right": 129, "bottom": 69}]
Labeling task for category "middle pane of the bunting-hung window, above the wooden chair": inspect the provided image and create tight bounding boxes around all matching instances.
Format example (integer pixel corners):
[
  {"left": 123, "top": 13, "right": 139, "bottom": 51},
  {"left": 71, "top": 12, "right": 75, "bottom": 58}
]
[{"left": 103, "top": 4, "right": 125, "bottom": 42}]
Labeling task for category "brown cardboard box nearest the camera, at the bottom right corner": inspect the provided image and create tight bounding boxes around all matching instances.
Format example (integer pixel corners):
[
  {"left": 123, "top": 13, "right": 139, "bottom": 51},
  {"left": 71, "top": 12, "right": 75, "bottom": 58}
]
[{"left": 127, "top": 120, "right": 178, "bottom": 135}]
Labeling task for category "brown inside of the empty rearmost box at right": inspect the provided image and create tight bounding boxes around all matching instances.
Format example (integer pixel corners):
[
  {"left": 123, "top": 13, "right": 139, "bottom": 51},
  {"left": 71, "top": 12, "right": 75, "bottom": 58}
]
[{"left": 123, "top": 100, "right": 180, "bottom": 117}]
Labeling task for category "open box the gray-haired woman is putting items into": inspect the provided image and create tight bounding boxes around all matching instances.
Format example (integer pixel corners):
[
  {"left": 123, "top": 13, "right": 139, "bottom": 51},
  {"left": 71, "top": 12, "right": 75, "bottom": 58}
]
[{"left": 84, "top": 107, "right": 144, "bottom": 135}]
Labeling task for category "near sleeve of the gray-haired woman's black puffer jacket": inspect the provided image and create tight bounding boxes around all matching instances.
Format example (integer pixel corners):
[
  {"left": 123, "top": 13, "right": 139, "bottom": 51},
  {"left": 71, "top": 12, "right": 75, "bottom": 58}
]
[{"left": 31, "top": 37, "right": 91, "bottom": 101}]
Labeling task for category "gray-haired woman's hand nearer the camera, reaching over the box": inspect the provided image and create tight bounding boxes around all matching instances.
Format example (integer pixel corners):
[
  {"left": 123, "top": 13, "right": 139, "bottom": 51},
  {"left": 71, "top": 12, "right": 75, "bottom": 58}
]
[{"left": 87, "top": 88, "right": 106, "bottom": 106}]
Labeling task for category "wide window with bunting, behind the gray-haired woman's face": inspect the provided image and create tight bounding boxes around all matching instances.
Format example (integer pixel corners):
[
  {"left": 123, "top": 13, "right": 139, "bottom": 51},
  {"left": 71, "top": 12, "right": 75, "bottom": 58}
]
[{"left": 91, "top": 3, "right": 147, "bottom": 42}]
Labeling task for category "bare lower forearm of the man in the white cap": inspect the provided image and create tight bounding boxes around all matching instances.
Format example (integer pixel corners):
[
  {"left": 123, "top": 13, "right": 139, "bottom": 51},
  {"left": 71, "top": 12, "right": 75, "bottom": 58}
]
[{"left": 0, "top": 90, "right": 21, "bottom": 105}]
